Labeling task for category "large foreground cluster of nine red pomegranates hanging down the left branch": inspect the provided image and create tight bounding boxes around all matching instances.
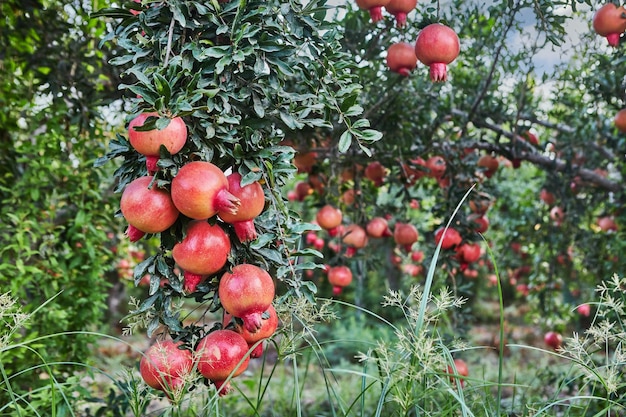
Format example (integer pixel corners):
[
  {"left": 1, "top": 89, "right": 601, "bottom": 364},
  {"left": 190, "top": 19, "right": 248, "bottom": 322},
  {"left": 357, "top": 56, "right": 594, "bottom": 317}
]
[{"left": 120, "top": 113, "right": 278, "bottom": 394}]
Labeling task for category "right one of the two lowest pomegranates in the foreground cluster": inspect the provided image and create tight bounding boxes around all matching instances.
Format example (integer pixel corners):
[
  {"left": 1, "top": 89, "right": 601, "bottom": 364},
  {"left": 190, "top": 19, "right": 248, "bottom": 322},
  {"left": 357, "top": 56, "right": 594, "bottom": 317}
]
[{"left": 196, "top": 329, "right": 250, "bottom": 395}]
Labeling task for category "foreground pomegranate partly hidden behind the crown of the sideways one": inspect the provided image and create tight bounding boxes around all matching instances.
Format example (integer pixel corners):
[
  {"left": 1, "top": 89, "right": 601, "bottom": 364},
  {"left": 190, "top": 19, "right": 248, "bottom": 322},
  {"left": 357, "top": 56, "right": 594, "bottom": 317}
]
[{"left": 218, "top": 172, "right": 265, "bottom": 243}]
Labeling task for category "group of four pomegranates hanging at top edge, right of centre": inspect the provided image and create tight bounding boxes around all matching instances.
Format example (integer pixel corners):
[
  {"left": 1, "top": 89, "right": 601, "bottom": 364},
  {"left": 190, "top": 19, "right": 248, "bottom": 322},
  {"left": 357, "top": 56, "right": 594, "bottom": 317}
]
[{"left": 356, "top": 0, "right": 460, "bottom": 82}]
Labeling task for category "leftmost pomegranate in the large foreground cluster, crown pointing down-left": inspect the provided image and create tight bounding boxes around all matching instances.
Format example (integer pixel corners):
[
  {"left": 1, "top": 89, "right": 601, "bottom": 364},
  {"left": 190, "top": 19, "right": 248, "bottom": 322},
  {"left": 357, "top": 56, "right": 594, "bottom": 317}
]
[{"left": 120, "top": 176, "right": 179, "bottom": 242}]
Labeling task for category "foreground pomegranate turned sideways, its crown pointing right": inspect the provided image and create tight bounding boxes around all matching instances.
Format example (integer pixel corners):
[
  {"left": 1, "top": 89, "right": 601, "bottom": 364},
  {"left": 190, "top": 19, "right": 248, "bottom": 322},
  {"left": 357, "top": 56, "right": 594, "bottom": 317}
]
[{"left": 172, "top": 161, "right": 241, "bottom": 220}]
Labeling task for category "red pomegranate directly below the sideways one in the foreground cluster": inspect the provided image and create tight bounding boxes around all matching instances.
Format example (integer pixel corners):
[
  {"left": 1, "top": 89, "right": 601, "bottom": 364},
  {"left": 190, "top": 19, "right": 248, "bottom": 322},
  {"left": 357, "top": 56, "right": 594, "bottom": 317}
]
[{"left": 172, "top": 220, "right": 231, "bottom": 293}]
